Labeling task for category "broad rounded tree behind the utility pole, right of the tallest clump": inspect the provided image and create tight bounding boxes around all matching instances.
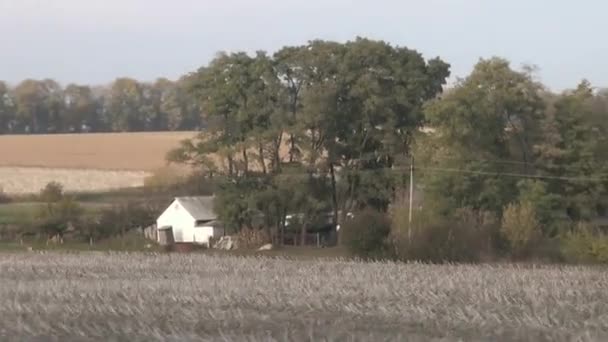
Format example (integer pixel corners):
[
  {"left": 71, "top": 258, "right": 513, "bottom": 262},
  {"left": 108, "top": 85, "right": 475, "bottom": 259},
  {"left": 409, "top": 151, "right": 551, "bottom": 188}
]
[{"left": 418, "top": 58, "right": 544, "bottom": 214}]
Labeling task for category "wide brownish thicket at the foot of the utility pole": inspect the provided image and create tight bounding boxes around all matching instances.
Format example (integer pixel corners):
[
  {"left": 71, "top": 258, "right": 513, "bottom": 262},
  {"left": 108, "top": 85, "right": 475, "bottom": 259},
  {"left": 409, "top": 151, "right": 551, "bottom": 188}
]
[{"left": 391, "top": 208, "right": 498, "bottom": 263}]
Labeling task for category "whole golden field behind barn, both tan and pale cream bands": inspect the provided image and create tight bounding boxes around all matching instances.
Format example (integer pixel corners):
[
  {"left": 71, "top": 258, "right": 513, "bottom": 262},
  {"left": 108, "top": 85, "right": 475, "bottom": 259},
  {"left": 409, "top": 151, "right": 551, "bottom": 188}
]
[{"left": 0, "top": 132, "right": 196, "bottom": 194}]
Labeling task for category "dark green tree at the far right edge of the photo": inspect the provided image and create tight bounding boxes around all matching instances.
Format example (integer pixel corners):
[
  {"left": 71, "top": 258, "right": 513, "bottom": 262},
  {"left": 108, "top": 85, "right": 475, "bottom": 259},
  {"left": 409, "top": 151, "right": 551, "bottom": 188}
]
[{"left": 536, "top": 81, "right": 608, "bottom": 221}]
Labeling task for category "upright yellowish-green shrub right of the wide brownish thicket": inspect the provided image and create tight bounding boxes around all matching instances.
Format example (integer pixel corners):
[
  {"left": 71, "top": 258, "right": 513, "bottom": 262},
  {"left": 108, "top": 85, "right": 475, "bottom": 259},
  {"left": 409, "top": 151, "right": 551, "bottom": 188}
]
[{"left": 500, "top": 201, "right": 542, "bottom": 256}]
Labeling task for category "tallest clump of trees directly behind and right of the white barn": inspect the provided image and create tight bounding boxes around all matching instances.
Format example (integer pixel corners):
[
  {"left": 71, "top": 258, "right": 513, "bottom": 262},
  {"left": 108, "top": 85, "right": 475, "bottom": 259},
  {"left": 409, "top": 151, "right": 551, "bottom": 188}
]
[{"left": 169, "top": 38, "right": 449, "bottom": 241}]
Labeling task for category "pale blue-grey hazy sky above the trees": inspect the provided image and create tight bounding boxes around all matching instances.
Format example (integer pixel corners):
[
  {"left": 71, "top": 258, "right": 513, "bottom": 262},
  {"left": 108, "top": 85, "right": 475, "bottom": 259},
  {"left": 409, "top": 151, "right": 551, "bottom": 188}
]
[{"left": 0, "top": 0, "right": 608, "bottom": 91}]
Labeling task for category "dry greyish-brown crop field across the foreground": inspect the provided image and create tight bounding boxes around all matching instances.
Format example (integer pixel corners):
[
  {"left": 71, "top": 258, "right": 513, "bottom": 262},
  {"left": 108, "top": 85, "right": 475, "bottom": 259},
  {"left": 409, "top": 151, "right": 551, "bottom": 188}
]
[{"left": 0, "top": 253, "right": 608, "bottom": 341}]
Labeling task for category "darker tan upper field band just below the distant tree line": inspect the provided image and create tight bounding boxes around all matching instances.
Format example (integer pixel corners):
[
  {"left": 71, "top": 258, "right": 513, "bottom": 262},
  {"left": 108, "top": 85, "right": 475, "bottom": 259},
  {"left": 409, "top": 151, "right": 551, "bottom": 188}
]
[{"left": 0, "top": 132, "right": 196, "bottom": 171}]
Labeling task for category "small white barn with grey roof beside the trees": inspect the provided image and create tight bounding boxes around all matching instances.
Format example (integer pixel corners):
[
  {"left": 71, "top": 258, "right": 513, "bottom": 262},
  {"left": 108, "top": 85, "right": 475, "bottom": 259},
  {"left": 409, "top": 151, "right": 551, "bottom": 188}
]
[{"left": 156, "top": 197, "right": 224, "bottom": 247}]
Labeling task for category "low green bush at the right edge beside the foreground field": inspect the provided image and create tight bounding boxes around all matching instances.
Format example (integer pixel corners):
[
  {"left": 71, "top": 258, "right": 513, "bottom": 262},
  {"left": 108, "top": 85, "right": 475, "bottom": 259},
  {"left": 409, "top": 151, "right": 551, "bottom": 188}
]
[{"left": 561, "top": 223, "right": 608, "bottom": 264}]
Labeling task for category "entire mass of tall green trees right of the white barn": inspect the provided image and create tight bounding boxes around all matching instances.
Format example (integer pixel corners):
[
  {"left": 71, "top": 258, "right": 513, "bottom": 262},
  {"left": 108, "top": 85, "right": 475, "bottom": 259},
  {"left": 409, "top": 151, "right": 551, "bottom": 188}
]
[{"left": 169, "top": 38, "right": 608, "bottom": 262}]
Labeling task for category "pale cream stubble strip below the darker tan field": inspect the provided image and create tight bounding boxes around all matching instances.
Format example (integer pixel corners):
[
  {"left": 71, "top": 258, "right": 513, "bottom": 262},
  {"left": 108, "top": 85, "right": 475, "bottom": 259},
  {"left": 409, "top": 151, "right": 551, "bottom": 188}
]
[{"left": 0, "top": 167, "right": 149, "bottom": 195}]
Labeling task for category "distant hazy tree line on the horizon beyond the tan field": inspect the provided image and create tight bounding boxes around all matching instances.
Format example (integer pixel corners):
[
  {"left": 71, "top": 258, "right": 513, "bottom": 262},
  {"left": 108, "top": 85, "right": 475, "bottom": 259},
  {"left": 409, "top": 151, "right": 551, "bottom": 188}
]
[{"left": 0, "top": 78, "right": 201, "bottom": 134}]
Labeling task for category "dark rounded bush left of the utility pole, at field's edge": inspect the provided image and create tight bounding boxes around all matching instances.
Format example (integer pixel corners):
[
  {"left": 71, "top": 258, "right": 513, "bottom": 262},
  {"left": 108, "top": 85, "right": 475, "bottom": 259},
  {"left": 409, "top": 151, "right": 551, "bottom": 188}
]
[{"left": 340, "top": 209, "right": 391, "bottom": 258}]
